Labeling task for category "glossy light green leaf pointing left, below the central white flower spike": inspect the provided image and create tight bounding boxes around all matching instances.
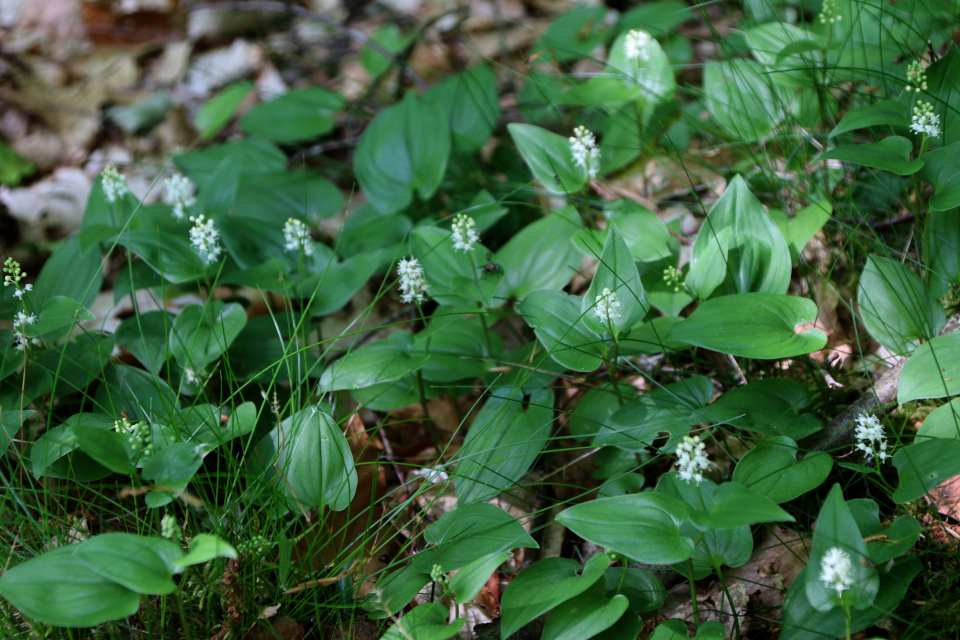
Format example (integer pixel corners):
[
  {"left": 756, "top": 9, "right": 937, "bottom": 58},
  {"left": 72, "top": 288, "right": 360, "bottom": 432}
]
[{"left": 320, "top": 331, "right": 428, "bottom": 393}]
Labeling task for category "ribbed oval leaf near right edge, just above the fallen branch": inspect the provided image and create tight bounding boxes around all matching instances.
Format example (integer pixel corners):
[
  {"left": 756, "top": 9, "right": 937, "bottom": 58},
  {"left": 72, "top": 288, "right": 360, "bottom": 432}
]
[{"left": 857, "top": 256, "right": 947, "bottom": 353}]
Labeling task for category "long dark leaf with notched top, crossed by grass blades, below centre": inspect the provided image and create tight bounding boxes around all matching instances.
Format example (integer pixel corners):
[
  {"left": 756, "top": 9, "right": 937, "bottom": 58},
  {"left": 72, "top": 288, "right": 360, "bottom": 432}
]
[{"left": 456, "top": 387, "right": 554, "bottom": 505}]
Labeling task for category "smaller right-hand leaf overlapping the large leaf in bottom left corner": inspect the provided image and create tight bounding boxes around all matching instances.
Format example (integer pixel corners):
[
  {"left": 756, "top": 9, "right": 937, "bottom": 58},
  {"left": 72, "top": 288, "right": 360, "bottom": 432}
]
[{"left": 73, "top": 533, "right": 182, "bottom": 596}]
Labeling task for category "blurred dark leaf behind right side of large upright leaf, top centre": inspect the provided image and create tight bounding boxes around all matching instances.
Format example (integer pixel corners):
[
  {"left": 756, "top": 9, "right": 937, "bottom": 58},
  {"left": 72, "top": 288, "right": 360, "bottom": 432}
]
[{"left": 423, "top": 65, "right": 500, "bottom": 152}]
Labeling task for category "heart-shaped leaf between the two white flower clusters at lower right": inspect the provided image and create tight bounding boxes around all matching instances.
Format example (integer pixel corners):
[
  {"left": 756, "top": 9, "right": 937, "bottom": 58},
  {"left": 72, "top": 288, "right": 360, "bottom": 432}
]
[{"left": 733, "top": 436, "right": 833, "bottom": 504}]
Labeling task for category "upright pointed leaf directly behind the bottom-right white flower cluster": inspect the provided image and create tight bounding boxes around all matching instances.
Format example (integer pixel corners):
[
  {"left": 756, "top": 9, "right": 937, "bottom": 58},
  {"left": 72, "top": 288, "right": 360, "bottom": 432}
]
[{"left": 805, "top": 488, "right": 876, "bottom": 611}]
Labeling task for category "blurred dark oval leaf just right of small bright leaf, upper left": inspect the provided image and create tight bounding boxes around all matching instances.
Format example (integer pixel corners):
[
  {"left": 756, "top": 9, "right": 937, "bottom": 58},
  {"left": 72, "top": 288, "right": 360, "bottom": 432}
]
[{"left": 240, "top": 87, "right": 343, "bottom": 143}]
